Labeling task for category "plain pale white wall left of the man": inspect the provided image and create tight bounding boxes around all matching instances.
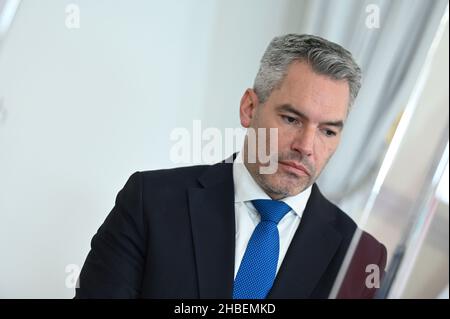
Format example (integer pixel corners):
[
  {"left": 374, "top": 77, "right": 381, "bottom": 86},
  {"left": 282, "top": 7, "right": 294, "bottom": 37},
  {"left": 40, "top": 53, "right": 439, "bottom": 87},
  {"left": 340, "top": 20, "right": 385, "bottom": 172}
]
[{"left": 0, "top": 0, "right": 295, "bottom": 298}]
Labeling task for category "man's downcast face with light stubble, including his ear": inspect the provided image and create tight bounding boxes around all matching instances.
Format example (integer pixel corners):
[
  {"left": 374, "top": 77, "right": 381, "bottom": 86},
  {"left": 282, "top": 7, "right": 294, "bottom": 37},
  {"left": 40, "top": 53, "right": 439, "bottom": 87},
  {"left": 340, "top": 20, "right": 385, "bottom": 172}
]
[{"left": 240, "top": 62, "right": 349, "bottom": 199}]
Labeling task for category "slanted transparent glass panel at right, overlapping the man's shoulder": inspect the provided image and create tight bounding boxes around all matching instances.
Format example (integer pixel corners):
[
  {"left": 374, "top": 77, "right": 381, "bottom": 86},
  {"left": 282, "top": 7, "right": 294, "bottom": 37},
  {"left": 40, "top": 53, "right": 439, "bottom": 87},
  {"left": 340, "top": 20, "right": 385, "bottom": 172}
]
[{"left": 330, "top": 11, "right": 449, "bottom": 298}]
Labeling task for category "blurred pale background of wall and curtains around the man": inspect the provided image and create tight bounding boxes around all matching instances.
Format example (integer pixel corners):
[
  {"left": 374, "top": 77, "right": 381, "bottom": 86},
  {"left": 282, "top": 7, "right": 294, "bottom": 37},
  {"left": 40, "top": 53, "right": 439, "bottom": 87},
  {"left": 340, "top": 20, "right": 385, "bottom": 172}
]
[{"left": 0, "top": 0, "right": 449, "bottom": 298}]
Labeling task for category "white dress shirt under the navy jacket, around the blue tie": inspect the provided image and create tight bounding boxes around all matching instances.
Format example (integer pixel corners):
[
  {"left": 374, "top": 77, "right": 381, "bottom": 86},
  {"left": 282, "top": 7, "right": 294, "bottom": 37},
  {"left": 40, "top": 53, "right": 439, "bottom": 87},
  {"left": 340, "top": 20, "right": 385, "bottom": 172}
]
[{"left": 233, "top": 152, "right": 311, "bottom": 278}]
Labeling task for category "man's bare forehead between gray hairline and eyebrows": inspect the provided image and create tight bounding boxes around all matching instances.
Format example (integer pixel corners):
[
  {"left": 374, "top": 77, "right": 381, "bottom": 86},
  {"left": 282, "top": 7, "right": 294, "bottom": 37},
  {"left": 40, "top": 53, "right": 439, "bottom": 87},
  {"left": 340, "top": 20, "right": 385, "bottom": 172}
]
[{"left": 268, "top": 62, "right": 350, "bottom": 121}]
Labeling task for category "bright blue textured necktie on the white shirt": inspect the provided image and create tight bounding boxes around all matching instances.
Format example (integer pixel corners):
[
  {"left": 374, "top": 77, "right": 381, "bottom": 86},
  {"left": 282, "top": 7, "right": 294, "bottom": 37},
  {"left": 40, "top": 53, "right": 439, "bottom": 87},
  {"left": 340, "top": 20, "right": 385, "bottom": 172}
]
[{"left": 233, "top": 199, "right": 291, "bottom": 299}]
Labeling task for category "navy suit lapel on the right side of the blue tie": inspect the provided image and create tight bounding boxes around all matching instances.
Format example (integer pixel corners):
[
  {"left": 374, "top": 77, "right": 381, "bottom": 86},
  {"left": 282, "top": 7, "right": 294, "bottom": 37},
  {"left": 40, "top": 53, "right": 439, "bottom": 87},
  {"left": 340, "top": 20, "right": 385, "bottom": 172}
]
[{"left": 268, "top": 184, "right": 342, "bottom": 299}]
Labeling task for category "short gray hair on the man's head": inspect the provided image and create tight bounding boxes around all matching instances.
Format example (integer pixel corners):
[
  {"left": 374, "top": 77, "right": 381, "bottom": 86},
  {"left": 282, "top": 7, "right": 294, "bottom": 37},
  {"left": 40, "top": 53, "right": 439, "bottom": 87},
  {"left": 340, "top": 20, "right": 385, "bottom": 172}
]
[{"left": 253, "top": 34, "right": 361, "bottom": 107}]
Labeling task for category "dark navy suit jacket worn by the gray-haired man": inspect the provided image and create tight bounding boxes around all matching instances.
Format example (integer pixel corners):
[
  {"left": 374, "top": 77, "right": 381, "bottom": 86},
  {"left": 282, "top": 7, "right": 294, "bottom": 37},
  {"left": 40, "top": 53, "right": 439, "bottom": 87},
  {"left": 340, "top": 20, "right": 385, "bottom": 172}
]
[{"left": 75, "top": 162, "right": 386, "bottom": 298}]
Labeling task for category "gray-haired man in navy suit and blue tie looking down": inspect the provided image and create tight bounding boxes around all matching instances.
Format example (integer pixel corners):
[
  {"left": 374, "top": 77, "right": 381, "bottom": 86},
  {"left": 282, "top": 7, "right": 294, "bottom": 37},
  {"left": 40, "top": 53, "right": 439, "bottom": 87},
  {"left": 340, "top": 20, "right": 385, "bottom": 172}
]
[{"left": 76, "top": 34, "right": 386, "bottom": 299}]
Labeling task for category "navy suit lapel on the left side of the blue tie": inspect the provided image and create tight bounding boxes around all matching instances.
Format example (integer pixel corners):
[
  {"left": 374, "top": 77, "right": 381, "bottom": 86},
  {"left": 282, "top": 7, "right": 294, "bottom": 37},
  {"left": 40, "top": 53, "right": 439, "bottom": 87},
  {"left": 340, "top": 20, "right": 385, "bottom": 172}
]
[{"left": 189, "top": 163, "right": 235, "bottom": 298}]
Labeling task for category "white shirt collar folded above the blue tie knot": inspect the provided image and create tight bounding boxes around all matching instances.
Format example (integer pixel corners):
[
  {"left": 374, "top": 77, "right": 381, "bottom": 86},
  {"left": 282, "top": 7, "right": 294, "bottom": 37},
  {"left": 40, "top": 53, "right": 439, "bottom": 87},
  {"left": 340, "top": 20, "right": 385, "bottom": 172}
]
[{"left": 233, "top": 152, "right": 311, "bottom": 217}]
